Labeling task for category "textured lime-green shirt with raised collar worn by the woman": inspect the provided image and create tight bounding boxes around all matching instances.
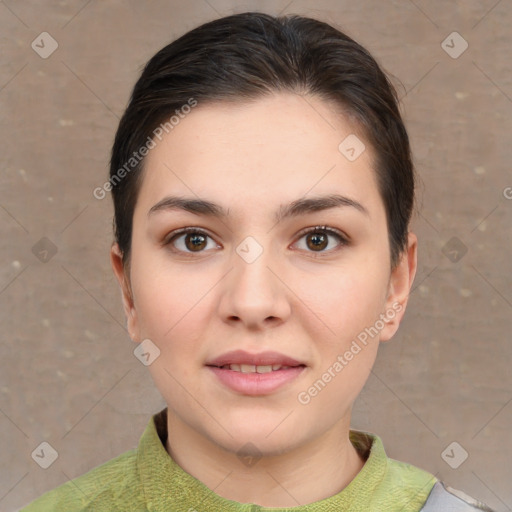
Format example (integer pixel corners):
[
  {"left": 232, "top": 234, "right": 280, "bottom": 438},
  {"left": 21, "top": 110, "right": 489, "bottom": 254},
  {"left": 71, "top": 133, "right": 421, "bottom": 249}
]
[{"left": 21, "top": 409, "right": 437, "bottom": 512}]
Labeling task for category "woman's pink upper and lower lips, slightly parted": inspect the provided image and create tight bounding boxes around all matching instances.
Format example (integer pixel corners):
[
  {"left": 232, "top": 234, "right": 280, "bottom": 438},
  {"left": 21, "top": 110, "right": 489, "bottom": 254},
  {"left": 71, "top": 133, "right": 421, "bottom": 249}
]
[{"left": 206, "top": 350, "right": 306, "bottom": 396}]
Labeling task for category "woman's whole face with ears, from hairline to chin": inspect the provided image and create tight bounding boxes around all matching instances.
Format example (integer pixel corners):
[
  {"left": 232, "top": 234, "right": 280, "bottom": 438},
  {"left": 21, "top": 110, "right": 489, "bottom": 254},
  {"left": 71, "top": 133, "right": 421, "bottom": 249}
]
[{"left": 112, "top": 93, "right": 415, "bottom": 454}]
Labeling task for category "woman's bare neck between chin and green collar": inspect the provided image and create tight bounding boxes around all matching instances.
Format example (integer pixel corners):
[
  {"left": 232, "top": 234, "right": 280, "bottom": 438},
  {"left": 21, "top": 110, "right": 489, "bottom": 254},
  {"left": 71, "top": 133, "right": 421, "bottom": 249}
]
[{"left": 166, "top": 410, "right": 365, "bottom": 508}]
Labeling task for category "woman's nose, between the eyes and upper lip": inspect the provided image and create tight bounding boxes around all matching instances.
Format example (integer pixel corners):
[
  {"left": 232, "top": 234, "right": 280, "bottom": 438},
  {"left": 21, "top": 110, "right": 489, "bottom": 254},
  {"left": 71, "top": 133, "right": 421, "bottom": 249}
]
[{"left": 219, "top": 241, "right": 291, "bottom": 330}]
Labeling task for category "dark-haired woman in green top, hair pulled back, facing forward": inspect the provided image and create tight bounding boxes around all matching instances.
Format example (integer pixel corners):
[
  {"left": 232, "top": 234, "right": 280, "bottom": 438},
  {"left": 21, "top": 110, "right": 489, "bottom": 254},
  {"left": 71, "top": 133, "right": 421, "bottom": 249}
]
[{"left": 21, "top": 13, "right": 496, "bottom": 512}]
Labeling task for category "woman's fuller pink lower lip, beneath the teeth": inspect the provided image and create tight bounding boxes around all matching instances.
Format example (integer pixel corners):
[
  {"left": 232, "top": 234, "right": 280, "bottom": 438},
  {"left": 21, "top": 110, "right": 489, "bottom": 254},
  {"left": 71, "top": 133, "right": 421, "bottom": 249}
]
[{"left": 208, "top": 366, "right": 306, "bottom": 396}]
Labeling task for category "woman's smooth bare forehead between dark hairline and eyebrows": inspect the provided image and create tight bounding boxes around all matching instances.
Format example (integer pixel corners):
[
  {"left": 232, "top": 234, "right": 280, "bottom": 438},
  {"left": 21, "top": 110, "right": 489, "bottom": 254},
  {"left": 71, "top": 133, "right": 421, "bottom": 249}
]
[{"left": 138, "top": 93, "right": 380, "bottom": 218}]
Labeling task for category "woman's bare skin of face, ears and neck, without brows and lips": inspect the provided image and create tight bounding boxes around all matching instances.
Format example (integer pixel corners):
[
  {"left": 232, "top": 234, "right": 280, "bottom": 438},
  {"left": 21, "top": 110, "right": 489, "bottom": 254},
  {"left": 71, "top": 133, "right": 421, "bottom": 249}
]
[{"left": 111, "top": 92, "right": 417, "bottom": 507}]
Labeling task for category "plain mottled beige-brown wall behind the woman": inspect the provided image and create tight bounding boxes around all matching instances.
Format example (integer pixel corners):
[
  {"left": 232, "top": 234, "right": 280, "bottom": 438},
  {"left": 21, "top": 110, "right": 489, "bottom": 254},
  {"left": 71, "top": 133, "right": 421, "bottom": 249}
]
[{"left": 0, "top": 0, "right": 512, "bottom": 512}]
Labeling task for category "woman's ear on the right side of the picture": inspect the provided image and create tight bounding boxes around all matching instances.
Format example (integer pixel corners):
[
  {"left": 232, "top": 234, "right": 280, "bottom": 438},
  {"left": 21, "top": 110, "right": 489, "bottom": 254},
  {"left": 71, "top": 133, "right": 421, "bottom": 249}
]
[{"left": 380, "top": 233, "right": 418, "bottom": 341}]
